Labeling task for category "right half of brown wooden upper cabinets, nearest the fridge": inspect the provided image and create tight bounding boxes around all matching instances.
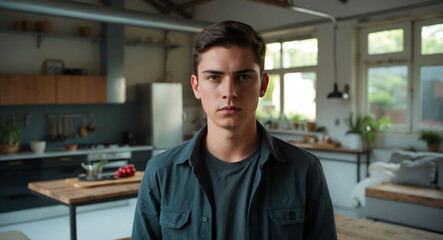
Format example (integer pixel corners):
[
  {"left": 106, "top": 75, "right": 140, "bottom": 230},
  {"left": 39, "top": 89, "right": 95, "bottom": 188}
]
[{"left": 56, "top": 75, "right": 107, "bottom": 104}]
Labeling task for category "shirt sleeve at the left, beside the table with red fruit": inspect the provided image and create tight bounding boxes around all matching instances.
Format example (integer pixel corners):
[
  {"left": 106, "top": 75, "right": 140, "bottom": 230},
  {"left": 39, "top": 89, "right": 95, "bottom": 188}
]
[{"left": 131, "top": 167, "right": 162, "bottom": 240}]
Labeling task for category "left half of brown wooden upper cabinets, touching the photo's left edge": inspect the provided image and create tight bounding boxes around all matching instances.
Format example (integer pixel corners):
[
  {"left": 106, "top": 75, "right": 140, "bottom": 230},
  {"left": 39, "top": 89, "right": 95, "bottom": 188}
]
[{"left": 0, "top": 74, "right": 56, "bottom": 105}]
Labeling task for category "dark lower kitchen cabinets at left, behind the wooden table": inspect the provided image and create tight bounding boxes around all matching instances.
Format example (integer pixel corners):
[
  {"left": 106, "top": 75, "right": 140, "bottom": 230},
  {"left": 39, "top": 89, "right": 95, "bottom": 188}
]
[{"left": 0, "top": 155, "right": 86, "bottom": 213}]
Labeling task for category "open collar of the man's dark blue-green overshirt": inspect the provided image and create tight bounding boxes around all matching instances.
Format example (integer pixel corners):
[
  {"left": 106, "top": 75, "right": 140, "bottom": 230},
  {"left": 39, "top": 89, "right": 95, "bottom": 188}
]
[{"left": 177, "top": 121, "right": 285, "bottom": 167}]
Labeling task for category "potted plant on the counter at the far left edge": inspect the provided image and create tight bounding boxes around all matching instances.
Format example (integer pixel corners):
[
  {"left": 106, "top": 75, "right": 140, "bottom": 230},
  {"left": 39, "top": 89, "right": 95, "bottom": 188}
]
[{"left": 0, "top": 119, "right": 21, "bottom": 154}]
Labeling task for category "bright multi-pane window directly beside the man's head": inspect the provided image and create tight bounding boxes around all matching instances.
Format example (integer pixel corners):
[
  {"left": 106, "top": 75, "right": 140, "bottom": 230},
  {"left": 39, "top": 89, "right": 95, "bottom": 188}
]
[{"left": 257, "top": 37, "right": 318, "bottom": 129}]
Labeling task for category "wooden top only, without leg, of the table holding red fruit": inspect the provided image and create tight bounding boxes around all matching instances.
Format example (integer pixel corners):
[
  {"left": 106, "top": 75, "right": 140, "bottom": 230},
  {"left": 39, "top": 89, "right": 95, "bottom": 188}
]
[{"left": 28, "top": 172, "right": 143, "bottom": 205}]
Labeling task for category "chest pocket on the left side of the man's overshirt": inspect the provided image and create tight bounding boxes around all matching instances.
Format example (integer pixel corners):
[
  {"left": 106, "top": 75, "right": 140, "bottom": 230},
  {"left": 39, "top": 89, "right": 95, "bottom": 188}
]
[{"left": 159, "top": 208, "right": 190, "bottom": 239}]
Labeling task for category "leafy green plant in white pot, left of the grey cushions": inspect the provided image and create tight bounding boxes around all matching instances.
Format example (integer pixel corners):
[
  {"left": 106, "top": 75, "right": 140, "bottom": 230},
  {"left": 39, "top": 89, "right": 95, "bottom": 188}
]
[{"left": 345, "top": 112, "right": 391, "bottom": 149}]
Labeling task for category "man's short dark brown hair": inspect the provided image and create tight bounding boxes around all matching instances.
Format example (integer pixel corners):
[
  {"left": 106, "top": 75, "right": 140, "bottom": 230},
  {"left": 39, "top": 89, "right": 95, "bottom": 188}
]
[{"left": 192, "top": 21, "right": 266, "bottom": 75}]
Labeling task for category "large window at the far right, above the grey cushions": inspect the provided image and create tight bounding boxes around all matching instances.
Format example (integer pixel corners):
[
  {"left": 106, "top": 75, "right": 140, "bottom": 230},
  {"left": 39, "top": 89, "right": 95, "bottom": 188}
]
[{"left": 359, "top": 18, "right": 443, "bottom": 132}]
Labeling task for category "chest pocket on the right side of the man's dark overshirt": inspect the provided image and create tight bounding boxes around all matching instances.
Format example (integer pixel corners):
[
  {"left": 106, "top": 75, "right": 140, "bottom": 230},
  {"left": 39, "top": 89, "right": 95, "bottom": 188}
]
[{"left": 268, "top": 206, "right": 305, "bottom": 240}]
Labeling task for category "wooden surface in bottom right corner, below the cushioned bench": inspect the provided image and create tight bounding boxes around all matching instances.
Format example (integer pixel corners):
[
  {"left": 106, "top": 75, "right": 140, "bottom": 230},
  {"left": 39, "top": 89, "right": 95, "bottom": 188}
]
[{"left": 335, "top": 214, "right": 443, "bottom": 240}]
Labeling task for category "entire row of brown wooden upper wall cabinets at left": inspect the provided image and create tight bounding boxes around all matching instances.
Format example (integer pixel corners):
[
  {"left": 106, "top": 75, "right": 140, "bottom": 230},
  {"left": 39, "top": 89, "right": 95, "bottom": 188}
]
[{"left": 0, "top": 74, "right": 107, "bottom": 105}]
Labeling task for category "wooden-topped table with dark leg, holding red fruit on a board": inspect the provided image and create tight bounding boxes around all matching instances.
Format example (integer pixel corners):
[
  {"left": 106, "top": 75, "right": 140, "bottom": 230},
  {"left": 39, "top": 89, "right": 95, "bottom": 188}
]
[{"left": 28, "top": 172, "right": 144, "bottom": 240}]
